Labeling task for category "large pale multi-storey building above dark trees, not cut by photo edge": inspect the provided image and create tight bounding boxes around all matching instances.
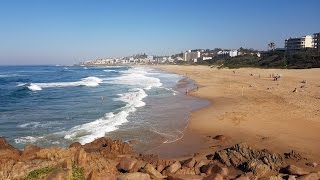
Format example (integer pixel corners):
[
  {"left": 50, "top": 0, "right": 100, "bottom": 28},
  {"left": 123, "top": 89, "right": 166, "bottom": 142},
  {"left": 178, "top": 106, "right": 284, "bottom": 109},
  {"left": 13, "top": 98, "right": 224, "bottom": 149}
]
[{"left": 285, "top": 35, "right": 313, "bottom": 51}]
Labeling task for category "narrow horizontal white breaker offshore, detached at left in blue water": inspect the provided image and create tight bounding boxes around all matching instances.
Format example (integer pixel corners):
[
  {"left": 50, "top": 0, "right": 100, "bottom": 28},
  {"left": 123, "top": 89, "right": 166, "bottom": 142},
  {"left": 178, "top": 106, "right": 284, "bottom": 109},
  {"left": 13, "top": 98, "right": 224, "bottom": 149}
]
[{"left": 28, "top": 76, "right": 102, "bottom": 91}]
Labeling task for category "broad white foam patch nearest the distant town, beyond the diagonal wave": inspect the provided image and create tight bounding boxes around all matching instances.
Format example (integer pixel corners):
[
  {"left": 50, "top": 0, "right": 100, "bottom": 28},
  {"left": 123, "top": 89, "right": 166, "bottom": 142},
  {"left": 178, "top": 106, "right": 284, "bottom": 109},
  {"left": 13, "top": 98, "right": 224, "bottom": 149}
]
[{"left": 105, "top": 68, "right": 162, "bottom": 90}]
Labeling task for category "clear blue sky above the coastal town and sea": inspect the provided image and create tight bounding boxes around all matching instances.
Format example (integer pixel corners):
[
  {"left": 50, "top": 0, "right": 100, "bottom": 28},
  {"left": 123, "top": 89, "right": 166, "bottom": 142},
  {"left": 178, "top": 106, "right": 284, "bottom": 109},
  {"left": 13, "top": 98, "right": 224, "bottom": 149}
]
[{"left": 0, "top": 0, "right": 320, "bottom": 64}]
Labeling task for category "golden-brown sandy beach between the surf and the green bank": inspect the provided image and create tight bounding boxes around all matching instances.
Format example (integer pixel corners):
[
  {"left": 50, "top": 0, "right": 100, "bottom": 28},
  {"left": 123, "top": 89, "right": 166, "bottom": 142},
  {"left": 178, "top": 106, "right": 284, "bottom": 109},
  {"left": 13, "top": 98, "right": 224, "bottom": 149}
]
[{"left": 151, "top": 66, "right": 320, "bottom": 161}]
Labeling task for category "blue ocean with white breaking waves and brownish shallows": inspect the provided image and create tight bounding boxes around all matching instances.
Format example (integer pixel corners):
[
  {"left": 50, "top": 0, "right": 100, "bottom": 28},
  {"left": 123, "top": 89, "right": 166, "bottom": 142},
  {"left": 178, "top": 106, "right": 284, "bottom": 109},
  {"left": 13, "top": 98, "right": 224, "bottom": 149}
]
[{"left": 0, "top": 66, "right": 208, "bottom": 152}]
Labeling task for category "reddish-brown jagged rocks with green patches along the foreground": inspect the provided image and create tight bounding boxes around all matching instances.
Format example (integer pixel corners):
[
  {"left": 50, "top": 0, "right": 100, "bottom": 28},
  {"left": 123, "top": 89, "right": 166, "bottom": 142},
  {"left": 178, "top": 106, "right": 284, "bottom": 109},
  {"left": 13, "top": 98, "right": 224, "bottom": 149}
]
[{"left": 0, "top": 138, "right": 320, "bottom": 180}]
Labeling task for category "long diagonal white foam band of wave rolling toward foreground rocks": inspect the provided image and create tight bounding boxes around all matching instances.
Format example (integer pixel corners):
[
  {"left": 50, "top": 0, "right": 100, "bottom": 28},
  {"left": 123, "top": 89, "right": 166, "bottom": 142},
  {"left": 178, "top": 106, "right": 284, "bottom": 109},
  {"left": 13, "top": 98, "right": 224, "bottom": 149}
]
[{"left": 64, "top": 88, "right": 147, "bottom": 144}]
